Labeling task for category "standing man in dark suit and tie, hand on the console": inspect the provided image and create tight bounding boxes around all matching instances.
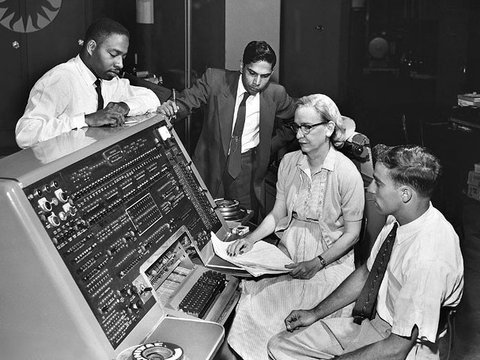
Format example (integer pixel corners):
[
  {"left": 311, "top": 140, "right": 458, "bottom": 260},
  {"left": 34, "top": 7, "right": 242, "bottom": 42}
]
[{"left": 159, "top": 41, "right": 296, "bottom": 218}]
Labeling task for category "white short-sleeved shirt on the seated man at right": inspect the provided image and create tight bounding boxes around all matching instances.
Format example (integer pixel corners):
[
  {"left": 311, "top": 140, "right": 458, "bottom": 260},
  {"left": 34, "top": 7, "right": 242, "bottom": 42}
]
[{"left": 367, "top": 204, "right": 463, "bottom": 343}]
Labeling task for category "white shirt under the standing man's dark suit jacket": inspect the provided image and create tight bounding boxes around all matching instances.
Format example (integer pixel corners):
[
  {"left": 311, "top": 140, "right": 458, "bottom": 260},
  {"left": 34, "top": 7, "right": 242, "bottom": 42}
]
[{"left": 232, "top": 77, "right": 260, "bottom": 153}]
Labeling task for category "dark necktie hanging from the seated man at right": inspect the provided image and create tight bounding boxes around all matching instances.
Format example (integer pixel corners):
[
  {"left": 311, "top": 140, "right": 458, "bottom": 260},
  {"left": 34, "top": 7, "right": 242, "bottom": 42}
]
[{"left": 352, "top": 223, "right": 398, "bottom": 324}]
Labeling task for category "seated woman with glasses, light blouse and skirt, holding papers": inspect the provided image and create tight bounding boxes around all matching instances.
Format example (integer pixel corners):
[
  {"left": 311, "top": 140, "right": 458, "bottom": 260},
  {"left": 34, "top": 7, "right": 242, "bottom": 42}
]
[{"left": 227, "top": 94, "right": 365, "bottom": 360}]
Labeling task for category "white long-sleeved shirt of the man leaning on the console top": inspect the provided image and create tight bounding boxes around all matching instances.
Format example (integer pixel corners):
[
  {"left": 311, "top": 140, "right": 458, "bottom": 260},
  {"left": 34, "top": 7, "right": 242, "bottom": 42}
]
[{"left": 15, "top": 55, "right": 160, "bottom": 148}]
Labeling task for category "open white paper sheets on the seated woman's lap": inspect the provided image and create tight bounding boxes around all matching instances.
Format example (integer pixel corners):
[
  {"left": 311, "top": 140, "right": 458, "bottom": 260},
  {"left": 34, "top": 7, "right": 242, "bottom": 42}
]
[{"left": 212, "top": 233, "right": 293, "bottom": 276}]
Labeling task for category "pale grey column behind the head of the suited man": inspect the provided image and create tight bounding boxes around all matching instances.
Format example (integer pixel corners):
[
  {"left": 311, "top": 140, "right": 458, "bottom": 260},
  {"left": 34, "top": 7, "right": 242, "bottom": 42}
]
[{"left": 225, "top": 0, "right": 281, "bottom": 81}]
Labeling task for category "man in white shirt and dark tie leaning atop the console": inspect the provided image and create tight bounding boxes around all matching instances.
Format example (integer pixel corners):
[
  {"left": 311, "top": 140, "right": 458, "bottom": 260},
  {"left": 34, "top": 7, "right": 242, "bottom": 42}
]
[{"left": 15, "top": 18, "right": 160, "bottom": 148}]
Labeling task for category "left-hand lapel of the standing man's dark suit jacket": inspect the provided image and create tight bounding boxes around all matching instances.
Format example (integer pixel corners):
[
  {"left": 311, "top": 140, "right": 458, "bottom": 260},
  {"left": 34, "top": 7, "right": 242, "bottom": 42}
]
[{"left": 217, "top": 73, "right": 240, "bottom": 155}]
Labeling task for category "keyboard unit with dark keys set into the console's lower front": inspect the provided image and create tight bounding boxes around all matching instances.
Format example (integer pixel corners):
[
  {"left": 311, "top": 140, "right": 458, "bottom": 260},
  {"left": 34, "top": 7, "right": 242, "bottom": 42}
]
[{"left": 140, "top": 226, "right": 239, "bottom": 324}]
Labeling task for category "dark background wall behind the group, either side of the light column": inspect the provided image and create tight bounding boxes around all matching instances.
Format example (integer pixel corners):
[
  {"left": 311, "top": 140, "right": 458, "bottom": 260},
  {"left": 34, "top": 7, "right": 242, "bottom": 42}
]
[{"left": 0, "top": 0, "right": 480, "bottom": 156}]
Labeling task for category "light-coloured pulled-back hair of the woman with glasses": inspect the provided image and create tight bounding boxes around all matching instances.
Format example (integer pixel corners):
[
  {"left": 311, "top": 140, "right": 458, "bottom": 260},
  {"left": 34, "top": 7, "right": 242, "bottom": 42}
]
[{"left": 297, "top": 94, "right": 346, "bottom": 148}]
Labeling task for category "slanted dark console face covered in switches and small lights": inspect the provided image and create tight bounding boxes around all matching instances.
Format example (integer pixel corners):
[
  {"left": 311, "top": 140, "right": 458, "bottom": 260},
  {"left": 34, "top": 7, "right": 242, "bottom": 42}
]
[{"left": 24, "top": 122, "right": 222, "bottom": 348}]
